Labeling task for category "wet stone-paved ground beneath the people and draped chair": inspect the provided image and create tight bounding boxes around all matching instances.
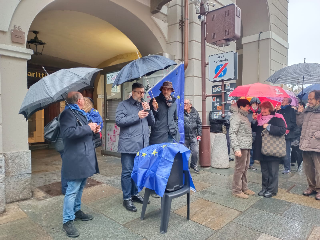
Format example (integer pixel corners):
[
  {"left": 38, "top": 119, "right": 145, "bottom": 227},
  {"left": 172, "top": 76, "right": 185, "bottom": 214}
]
[{"left": 0, "top": 150, "right": 320, "bottom": 240}]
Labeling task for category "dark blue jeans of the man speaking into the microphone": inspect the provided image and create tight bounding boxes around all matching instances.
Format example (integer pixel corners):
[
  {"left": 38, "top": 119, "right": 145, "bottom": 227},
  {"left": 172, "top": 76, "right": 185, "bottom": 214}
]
[{"left": 121, "top": 153, "right": 138, "bottom": 200}]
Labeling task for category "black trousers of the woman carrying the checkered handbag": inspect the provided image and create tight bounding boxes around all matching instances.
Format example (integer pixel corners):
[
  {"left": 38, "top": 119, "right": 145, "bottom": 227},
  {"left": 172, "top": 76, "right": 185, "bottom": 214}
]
[{"left": 260, "top": 161, "right": 279, "bottom": 193}]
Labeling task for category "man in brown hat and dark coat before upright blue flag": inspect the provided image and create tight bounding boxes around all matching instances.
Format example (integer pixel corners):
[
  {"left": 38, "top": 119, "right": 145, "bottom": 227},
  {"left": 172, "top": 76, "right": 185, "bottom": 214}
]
[{"left": 150, "top": 81, "right": 180, "bottom": 145}]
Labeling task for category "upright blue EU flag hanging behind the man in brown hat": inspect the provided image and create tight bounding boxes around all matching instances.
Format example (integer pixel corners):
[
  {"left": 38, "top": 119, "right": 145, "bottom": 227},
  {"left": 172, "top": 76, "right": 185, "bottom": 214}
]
[{"left": 148, "top": 63, "right": 184, "bottom": 143}]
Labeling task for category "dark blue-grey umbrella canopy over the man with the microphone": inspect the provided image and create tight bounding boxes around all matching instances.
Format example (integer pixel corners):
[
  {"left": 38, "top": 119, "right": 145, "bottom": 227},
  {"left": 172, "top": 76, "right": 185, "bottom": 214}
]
[{"left": 113, "top": 55, "right": 177, "bottom": 87}]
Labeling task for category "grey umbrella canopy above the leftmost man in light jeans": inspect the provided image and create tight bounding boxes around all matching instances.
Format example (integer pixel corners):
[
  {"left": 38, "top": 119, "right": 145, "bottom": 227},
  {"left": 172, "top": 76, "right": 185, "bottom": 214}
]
[{"left": 19, "top": 68, "right": 102, "bottom": 119}]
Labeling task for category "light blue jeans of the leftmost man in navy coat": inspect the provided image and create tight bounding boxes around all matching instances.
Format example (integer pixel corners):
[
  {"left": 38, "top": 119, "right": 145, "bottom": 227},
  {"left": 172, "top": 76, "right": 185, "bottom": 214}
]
[{"left": 63, "top": 178, "right": 87, "bottom": 223}]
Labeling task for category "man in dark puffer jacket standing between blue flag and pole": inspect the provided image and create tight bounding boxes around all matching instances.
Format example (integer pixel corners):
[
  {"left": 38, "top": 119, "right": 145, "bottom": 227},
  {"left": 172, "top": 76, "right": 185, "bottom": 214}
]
[{"left": 184, "top": 99, "right": 202, "bottom": 173}]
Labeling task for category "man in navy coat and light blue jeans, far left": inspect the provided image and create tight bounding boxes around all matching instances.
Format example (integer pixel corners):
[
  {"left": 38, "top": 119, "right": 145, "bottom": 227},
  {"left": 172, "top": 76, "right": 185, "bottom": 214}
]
[{"left": 60, "top": 92, "right": 100, "bottom": 237}]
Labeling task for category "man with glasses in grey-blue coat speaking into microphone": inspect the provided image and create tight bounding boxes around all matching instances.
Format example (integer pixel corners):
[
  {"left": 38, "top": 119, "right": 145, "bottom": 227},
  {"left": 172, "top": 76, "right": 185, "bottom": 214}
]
[{"left": 116, "top": 83, "right": 154, "bottom": 212}]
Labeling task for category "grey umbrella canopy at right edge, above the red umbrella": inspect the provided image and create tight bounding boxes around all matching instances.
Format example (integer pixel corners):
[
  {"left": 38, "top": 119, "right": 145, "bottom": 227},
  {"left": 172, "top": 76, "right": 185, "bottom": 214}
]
[{"left": 267, "top": 63, "right": 320, "bottom": 85}]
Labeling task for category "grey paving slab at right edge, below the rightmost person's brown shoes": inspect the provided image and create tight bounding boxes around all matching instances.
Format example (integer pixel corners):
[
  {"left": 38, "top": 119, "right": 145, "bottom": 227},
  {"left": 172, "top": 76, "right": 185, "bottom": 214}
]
[{"left": 283, "top": 204, "right": 320, "bottom": 225}]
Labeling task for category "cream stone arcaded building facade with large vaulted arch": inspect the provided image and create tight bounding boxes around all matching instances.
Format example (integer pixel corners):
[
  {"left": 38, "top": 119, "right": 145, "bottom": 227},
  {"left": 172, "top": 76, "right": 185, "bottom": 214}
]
[{"left": 0, "top": 0, "right": 288, "bottom": 212}]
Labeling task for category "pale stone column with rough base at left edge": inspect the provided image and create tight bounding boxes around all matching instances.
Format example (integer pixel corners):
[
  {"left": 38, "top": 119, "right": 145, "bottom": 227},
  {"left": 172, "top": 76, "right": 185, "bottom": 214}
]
[{"left": 0, "top": 44, "right": 32, "bottom": 212}]
